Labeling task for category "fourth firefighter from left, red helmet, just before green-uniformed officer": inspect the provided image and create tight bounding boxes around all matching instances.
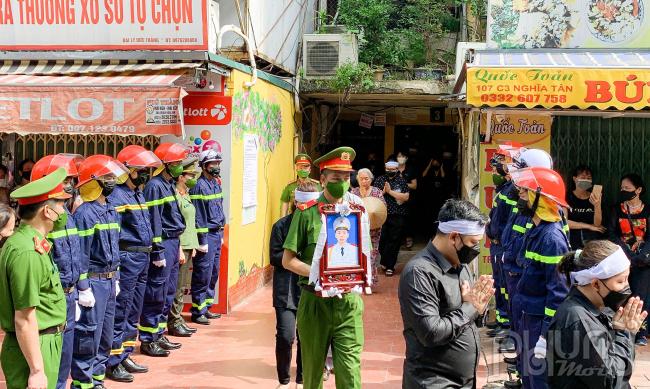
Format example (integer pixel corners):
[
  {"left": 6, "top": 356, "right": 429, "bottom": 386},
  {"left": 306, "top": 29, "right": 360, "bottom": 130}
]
[{"left": 138, "top": 143, "right": 188, "bottom": 357}]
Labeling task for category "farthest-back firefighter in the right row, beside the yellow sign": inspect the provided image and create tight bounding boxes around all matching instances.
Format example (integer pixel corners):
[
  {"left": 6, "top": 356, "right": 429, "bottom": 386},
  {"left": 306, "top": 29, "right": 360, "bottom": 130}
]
[{"left": 485, "top": 142, "right": 521, "bottom": 340}]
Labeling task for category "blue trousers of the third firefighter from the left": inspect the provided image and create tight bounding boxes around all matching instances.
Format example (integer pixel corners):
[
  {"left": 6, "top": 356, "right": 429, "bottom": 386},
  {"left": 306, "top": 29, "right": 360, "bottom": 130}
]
[{"left": 108, "top": 251, "right": 149, "bottom": 367}]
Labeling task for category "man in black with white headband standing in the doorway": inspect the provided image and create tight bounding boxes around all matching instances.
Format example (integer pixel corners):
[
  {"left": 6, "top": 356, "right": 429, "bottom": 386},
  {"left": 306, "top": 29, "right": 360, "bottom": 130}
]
[{"left": 373, "top": 161, "right": 409, "bottom": 277}]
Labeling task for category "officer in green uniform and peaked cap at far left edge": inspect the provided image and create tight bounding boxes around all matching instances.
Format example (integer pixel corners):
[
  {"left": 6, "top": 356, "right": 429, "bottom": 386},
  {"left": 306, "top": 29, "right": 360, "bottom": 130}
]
[{"left": 0, "top": 168, "right": 71, "bottom": 389}]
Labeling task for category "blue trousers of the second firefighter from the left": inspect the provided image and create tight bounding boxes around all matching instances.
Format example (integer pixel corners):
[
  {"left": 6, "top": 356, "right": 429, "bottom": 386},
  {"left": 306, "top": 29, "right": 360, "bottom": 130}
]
[{"left": 71, "top": 277, "right": 115, "bottom": 389}]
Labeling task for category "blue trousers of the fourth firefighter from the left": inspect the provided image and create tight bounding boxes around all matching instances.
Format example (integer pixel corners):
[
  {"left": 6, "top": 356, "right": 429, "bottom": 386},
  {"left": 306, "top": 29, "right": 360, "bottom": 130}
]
[{"left": 138, "top": 238, "right": 180, "bottom": 342}]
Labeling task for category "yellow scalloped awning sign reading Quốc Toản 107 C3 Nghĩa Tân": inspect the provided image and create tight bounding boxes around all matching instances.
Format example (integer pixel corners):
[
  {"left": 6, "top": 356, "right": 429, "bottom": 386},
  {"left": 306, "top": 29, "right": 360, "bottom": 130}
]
[{"left": 467, "top": 67, "right": 650, "bottom": 110}]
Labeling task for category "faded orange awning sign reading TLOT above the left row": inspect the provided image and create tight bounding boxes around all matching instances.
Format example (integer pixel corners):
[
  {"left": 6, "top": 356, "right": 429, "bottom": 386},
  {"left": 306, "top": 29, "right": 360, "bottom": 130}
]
[{"left": 0, "top": 87, "right": 182, "bottom": 135}]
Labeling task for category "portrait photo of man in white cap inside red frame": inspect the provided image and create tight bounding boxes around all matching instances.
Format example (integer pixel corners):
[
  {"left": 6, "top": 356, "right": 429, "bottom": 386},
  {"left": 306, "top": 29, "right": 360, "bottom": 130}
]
[{"left": 327, "top": 215, "right": 359, "bottom": 268}]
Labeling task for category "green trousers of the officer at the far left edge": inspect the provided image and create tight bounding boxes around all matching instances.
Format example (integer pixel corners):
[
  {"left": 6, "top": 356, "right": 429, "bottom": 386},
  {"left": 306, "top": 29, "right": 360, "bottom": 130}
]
[{"left": 0, "top": 333, "right": 63, "bottom": 389}]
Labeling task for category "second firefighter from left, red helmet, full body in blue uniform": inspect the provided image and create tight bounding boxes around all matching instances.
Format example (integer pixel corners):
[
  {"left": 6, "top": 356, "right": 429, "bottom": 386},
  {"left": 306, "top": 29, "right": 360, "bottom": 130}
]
[{"left": 71, "top": 155, "right": 127, "bottom": 389}]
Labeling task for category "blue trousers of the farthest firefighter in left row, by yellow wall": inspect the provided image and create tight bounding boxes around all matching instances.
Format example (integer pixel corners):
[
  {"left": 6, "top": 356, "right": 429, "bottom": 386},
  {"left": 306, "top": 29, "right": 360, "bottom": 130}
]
[{"left": 191, "top": 232, "right": 223, "bottom": 316}]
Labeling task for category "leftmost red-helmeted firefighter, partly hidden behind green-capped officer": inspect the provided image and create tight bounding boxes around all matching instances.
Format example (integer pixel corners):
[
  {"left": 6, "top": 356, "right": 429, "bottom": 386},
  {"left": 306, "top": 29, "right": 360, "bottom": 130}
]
[{"left": 31, "top": 154, "right": 87, "bottom": 389}]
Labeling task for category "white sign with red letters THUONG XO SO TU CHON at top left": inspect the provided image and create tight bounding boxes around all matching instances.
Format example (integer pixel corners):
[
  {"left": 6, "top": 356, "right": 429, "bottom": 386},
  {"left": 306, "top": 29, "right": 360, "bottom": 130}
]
[{"left": 0, "top": 0, "right": 208, "bottom": 50}]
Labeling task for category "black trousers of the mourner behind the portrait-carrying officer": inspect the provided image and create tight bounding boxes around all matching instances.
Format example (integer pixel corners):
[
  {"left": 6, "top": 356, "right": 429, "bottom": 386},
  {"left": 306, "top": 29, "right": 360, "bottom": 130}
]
[{"left": 275, "top": 307, "right": 302, "bottom": 385}]
